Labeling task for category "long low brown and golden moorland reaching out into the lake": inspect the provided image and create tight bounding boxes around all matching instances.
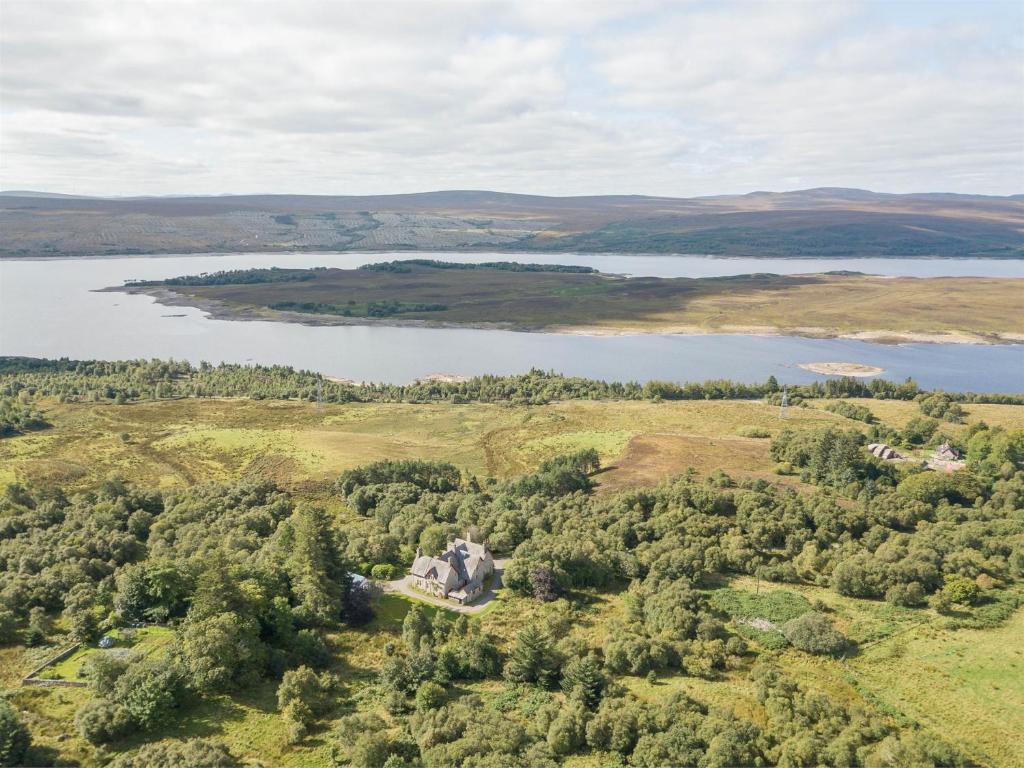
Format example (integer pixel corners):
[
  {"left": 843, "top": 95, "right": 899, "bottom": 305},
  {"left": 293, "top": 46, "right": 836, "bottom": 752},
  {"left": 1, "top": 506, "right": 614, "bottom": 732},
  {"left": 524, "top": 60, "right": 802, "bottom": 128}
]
[{"left": 106, "top": 259, "right": 1024, "bottom": 346}]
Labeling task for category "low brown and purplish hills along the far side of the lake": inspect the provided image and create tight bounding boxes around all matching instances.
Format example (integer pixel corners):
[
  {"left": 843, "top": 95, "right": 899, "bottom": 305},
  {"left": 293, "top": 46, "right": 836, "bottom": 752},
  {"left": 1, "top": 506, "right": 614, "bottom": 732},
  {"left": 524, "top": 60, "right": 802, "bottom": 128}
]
[{"left": 0, "top": 187, "right": 1024, "bottom": 258}]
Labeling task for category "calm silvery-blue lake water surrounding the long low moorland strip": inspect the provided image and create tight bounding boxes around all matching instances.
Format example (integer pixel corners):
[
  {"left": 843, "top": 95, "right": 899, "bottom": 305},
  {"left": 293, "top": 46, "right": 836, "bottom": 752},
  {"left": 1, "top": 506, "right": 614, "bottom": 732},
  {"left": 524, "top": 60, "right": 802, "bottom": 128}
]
[{"left": 0, "top": 253, "right": 1024, "bottom": 392}]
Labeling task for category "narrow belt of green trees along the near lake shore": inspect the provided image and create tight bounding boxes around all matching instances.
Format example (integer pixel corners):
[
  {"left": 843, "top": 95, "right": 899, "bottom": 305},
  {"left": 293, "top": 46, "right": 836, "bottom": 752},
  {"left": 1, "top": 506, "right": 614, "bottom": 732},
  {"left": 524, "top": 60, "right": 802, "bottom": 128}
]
[{"left": 0, "top": 357, "right": 1024, "bottom": 411}]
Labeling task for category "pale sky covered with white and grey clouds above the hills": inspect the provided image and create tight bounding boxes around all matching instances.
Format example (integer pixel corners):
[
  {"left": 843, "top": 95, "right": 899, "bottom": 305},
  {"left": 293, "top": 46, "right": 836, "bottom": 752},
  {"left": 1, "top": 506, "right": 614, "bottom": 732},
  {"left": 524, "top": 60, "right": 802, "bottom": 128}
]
[{"left": 0, "top": 0, "right": 1024, "bottom": 196}]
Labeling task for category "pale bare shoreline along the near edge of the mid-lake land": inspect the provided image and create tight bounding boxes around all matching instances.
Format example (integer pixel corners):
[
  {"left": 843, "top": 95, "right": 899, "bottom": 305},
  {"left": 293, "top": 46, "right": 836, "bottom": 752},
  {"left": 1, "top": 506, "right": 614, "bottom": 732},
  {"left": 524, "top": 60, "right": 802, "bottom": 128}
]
[{"left": 103, "top": 286, "right": 1024, "bottom": 346}]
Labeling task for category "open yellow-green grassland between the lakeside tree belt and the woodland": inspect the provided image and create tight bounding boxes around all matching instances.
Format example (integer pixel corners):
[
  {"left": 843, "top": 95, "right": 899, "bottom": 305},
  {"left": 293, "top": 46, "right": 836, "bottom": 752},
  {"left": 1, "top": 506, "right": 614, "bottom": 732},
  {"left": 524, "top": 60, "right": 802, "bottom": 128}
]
[{"left": 0, "top": 399, "right": 1024, "bottom": 492}]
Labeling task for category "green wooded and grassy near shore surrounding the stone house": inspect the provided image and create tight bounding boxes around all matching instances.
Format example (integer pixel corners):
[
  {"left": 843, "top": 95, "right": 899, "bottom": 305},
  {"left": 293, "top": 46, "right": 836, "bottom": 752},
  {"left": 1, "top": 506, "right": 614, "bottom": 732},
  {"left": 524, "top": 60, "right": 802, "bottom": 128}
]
[{"left": 0, "top": 358, "right": 1024, "bottom": 768}]
